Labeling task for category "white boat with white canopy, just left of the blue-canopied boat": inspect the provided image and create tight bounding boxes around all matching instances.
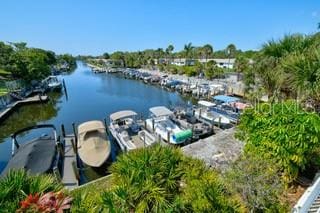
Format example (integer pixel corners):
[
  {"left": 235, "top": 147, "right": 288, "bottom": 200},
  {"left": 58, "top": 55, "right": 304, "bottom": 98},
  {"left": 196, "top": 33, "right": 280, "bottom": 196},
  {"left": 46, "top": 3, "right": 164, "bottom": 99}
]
[{"left": 194, "top": 101, "right": 231, "bottom": 125}]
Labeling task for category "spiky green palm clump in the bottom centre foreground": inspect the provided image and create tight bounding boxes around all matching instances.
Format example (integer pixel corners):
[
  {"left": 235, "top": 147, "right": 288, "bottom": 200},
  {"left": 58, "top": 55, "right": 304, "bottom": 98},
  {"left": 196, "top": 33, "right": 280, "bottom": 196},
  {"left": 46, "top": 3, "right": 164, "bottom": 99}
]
[{"left": 102, "top": 146, "right": 240, "bottom": 212}]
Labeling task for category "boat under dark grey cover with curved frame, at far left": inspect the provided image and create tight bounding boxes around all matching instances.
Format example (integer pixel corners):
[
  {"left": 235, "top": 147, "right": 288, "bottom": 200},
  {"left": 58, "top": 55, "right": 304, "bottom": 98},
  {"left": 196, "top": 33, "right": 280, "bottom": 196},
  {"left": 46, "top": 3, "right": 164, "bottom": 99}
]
[{"left": 1, "top": 124, "right": 63, "bottom": 176}]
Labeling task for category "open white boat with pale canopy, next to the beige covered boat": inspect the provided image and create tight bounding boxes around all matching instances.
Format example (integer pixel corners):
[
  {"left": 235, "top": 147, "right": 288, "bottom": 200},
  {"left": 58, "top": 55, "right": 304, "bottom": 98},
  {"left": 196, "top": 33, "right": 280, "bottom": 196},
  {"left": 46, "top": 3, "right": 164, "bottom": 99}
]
[{"left": 109, "top": 110, "right": 156, "bottom": 151}]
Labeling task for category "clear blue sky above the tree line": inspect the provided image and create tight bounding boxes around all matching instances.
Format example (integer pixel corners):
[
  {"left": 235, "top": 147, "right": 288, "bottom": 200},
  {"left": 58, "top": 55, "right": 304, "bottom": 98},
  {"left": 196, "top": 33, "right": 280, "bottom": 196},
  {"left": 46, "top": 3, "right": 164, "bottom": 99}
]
[{"left": 0, "top": 0, "right": 320, "bottom": 55}]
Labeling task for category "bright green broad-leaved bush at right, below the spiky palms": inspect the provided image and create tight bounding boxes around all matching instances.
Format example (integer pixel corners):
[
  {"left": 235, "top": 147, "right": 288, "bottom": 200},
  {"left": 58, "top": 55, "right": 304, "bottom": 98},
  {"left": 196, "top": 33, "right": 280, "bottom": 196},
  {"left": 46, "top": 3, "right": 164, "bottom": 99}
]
[{"left": 238, "top": 101, "right": 320, "bottom": 183}]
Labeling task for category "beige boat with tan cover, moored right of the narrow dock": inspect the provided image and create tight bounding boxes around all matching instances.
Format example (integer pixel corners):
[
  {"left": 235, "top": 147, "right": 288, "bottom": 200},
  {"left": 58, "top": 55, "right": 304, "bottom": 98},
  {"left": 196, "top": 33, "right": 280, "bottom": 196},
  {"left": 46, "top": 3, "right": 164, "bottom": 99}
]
[{"left": 78, "top": 121, "right": 111, "bottom": 167}]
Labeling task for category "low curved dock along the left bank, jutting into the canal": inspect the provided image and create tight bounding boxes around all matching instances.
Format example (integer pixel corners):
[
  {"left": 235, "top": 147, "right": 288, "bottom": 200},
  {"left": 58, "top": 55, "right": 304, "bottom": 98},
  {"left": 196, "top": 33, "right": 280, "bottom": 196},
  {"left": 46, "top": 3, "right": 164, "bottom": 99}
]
[{"left": 0, "top": 95, "right": 49, "bottom": 121}]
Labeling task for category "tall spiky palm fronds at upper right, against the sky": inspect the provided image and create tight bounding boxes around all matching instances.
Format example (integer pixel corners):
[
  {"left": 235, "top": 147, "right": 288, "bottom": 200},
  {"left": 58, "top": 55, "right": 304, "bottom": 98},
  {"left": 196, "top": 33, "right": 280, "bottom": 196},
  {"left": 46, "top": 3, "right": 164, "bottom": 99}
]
[{"left": 250, "top": 33, "right": 320, "bottom": 109}]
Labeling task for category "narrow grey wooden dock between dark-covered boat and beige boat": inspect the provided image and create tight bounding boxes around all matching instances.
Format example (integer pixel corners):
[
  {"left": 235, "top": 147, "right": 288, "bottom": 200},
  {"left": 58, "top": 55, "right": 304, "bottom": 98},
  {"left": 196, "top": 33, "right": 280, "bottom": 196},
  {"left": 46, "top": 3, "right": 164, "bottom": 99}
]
[{"left": 61, "top": 135, "right": 79, "bottom": 189}]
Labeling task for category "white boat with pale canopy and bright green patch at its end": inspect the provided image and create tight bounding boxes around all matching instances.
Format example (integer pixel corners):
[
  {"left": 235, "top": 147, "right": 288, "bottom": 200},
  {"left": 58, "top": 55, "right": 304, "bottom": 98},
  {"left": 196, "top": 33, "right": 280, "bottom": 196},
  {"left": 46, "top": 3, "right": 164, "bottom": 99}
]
[{"left": 146, "top": 106, "right": 192, "bottom": 144}]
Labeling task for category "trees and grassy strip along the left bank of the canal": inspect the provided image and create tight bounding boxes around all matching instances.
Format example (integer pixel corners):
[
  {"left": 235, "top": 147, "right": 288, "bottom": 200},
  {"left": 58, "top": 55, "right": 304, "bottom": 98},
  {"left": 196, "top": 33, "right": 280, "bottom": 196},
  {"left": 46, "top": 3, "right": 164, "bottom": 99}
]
[{"left": 0, "top": 41, "right": 76, "bottom": 96}]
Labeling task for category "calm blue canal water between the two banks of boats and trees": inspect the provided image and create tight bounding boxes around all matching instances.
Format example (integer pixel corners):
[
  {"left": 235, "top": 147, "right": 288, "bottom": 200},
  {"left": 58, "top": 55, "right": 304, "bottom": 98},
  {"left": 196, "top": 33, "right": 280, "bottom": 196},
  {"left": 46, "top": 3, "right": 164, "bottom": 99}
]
[{"left": 0, "top": 62, "right": 187, "bottom": 172}]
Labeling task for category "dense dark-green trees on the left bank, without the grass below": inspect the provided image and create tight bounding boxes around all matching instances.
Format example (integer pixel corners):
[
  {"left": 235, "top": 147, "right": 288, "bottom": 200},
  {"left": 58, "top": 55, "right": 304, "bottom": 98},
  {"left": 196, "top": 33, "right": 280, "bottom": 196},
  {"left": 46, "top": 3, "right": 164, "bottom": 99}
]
[{"left": 0, "top": 42, "right": 75, "bottom": 82}]
